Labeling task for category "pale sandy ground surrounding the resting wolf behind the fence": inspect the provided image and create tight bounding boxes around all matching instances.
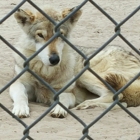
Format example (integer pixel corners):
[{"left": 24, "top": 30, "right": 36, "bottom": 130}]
[{"left": 0, "top": 0, "right": 140, "bottom": 140}]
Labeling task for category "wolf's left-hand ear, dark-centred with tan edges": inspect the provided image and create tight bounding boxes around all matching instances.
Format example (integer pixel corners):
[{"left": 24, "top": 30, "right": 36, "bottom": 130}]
[{"left": 14, "top": 9, "right": 35, "bottom": 31}]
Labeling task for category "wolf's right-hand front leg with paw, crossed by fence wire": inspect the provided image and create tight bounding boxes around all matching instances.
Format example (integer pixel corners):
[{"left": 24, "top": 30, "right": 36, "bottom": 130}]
[{"left": 50, "top": 92, "right": 76, "bottom": 118}]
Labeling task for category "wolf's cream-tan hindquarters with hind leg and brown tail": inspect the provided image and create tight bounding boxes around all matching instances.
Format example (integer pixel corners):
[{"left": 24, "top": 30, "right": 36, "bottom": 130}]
[{"left": 76, "top": 46, "right": 140, "bottom": 109}]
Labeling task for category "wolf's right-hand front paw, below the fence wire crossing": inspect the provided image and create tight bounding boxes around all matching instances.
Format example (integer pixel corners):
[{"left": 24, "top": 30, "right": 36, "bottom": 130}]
[{"left": 50, "top": 105, "right": 68, "bottom": 118}]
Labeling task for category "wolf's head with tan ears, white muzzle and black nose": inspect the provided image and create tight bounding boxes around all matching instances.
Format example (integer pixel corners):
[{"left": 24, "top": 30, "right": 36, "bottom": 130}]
[{"left": 14, "top": 7, "right": 82, "bottom": 66}]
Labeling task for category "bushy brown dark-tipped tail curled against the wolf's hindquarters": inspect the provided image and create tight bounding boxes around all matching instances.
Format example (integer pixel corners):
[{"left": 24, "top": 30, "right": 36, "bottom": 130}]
[{"left": 105, "top": 74, "right": 140, "bottom": 107}]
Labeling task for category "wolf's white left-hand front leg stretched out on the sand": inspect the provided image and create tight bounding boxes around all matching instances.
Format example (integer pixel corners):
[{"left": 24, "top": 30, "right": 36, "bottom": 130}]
[{"left": 10, "top": 81, "right": 30, "bottom": 118}]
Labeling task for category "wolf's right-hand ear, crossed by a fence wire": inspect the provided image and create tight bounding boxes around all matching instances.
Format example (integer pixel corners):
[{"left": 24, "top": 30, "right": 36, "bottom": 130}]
[{"left": 62, "top": 7, "right": 82, "bottom": 24}]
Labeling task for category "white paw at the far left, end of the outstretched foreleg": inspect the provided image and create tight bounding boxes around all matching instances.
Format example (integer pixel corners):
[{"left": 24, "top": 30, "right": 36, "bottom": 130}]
[{"left": 12, "top": 104, "right": 30, "bottom": 118}]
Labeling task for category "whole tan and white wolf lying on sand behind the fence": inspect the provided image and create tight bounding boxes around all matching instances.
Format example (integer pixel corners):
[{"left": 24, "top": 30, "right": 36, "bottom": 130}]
[{"left": 10, "top": 7, "right": 140, "bottom": 118}]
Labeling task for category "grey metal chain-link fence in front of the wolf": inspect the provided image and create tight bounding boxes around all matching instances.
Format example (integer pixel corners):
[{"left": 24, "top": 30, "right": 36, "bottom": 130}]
[{"left": 0, "top": 0, "right": 140, "bottom": 140}]
